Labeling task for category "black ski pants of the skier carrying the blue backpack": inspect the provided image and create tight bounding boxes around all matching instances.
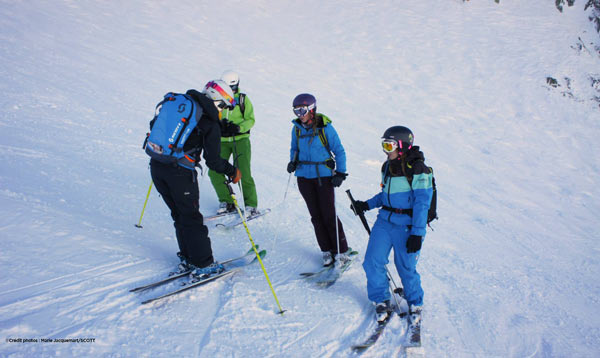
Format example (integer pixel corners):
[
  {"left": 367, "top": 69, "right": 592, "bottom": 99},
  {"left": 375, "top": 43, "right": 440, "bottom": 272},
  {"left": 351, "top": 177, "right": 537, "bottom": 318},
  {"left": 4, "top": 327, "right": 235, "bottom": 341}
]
[{"left": 150, "top": 160, "right": 214, "bottom": 267}]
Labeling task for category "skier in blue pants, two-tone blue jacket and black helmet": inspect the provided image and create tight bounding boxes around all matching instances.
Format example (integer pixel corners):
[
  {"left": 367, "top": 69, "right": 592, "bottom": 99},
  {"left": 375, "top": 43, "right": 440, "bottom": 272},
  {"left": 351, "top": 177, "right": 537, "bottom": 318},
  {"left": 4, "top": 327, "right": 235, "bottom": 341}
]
[{"left": 351, "top": 126, "right": 433, "bottom": 322}]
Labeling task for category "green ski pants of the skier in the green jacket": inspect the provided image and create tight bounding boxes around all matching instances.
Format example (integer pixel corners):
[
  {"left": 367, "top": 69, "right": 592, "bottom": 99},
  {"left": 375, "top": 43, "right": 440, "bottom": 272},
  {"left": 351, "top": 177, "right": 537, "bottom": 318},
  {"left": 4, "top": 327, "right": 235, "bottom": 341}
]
[{"left": 208, "top": 138, "right": 258, "bottom": 208}]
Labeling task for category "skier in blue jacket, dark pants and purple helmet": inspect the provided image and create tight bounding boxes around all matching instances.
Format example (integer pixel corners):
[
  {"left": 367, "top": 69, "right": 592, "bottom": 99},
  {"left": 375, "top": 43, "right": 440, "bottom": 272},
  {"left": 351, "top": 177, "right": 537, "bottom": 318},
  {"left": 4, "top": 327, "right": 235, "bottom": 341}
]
[{"left": 287, "top": 93, "right": 350, "bottom": 266}]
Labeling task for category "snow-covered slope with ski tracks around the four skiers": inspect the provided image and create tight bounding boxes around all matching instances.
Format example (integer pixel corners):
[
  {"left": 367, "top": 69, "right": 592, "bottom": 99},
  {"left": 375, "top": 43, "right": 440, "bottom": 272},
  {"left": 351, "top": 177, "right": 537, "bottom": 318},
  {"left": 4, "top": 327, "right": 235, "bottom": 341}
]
[{"left": 0, "top": 0, "right": 600, "bottom": 358}]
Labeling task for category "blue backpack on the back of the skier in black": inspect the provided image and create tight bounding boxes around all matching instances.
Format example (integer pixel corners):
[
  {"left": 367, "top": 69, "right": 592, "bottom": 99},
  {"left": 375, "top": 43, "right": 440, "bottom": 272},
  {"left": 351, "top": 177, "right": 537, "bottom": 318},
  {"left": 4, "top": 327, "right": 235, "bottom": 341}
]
[{"left": 144, "top": 92, "right": 202, "bottom": 169}]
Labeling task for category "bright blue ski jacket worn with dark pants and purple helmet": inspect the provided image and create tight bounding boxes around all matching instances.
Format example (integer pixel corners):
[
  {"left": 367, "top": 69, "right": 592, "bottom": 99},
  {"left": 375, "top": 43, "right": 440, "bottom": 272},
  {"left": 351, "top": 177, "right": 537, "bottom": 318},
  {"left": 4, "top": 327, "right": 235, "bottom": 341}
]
[{"left": 290, "top": 113, "right": 346, "bottom": 179}]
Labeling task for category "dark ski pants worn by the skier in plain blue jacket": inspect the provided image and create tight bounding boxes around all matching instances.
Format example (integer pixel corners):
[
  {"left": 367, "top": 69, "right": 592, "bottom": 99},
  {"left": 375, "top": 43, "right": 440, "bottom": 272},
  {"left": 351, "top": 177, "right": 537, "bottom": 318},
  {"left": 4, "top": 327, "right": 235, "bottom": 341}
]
[{"left": 298, "top": 177, "right": 348, "bottom": 255}]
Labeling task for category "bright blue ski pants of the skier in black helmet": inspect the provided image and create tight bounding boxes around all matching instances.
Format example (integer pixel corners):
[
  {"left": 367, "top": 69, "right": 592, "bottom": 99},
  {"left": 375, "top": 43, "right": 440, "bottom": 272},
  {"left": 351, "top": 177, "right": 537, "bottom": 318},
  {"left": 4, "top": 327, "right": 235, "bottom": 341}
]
[{"left": 363, "top": 219, "right": 423, "bottom": 305}]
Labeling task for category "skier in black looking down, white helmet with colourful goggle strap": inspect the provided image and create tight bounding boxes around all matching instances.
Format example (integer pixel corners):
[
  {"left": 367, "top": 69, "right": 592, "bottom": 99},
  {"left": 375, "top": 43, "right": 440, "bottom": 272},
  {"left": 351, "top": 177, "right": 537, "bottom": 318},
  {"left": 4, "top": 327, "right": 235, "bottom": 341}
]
[{"left": 146, "top": 80, "right": 241, "bottom": 278}]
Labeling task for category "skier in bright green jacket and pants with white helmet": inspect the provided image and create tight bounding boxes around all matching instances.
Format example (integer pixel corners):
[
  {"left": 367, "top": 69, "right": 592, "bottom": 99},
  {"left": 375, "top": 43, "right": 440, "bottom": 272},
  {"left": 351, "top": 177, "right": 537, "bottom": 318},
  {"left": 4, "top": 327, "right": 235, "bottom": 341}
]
[{"left": 208, "top": 71, "right": 258, "bottom": 216}]
